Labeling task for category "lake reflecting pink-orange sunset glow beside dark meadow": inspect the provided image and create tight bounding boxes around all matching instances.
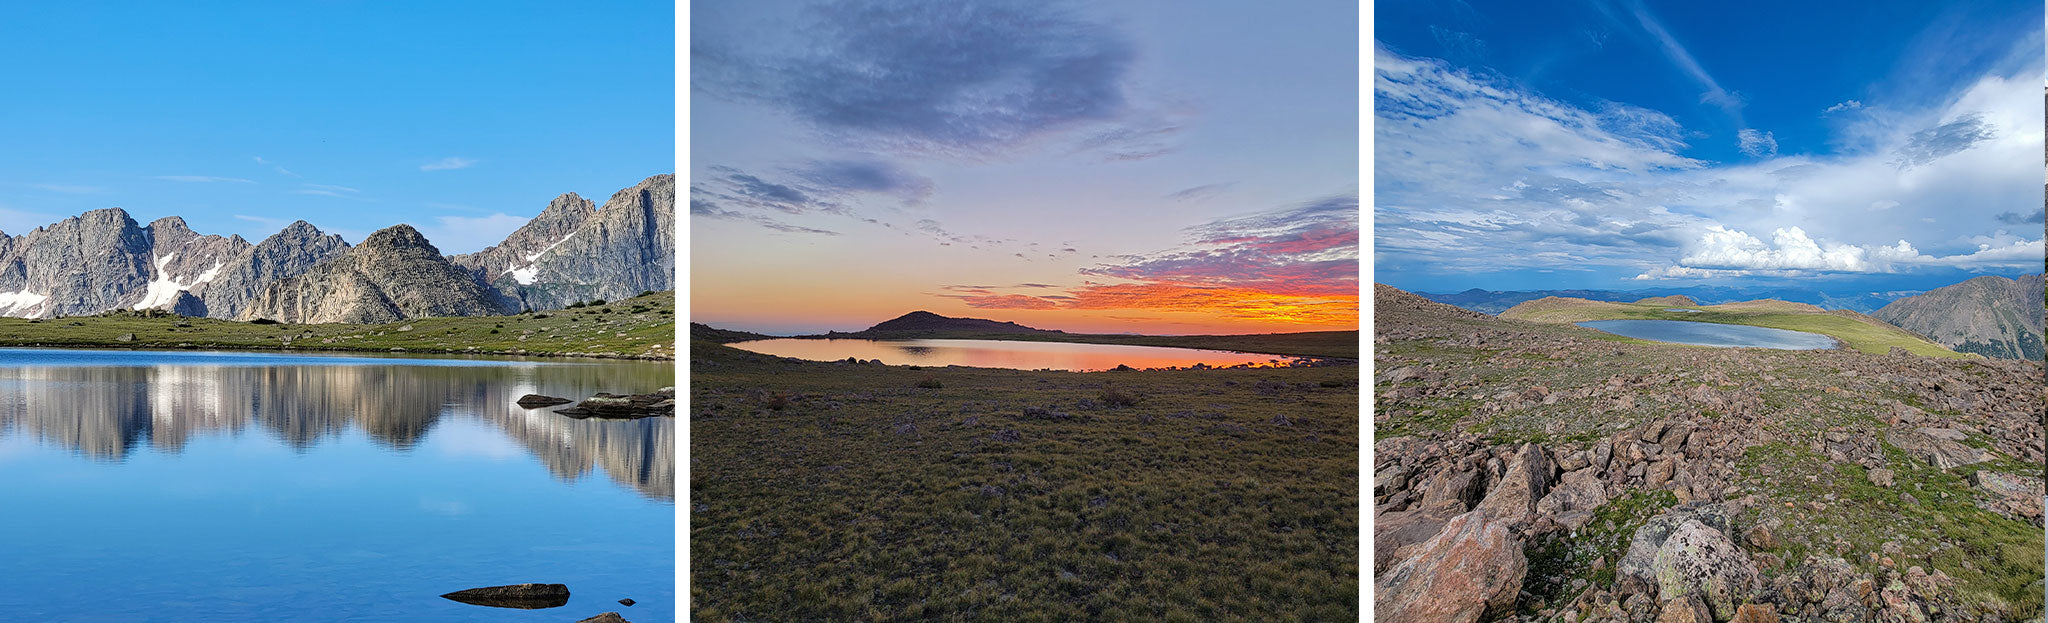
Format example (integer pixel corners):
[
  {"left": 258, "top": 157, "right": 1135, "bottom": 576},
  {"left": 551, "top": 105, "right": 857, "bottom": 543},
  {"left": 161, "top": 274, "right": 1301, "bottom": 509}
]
[{"left": 725, "top": 338, "right": 1292, "bottom": 371}]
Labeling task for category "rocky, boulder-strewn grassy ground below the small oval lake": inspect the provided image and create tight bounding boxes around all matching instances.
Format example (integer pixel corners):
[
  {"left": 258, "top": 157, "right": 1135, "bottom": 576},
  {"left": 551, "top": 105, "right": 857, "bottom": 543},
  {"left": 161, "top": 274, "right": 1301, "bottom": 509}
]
[{"left": 1372, "top": 285, "right": 2044, "bottom": 623}]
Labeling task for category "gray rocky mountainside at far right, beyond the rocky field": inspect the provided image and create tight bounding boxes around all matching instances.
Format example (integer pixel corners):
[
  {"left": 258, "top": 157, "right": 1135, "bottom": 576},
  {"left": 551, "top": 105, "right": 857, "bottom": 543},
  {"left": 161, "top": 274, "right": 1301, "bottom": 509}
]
[{"left": 1870, "top": 275, "right": 2044, "bottom": 359}]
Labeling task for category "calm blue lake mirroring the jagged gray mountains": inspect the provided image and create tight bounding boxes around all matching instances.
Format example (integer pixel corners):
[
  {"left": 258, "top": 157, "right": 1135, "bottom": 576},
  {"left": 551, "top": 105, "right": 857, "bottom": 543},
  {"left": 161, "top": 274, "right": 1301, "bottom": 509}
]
[{"left": 0, "top": 348, "right": 676, "bottom": 623}]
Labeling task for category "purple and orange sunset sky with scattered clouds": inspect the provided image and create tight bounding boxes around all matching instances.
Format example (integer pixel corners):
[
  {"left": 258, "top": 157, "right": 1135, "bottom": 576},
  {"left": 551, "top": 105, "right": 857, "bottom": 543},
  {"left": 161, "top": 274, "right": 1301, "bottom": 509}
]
[{"left": 688, "top": 0, "right": 1360, "bottom": 334}]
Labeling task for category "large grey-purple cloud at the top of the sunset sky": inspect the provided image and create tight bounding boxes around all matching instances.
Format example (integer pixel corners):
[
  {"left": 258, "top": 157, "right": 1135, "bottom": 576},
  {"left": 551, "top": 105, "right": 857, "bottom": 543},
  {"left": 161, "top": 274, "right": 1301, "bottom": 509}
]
[{"left": 692, "top": 0, "right": 1157, "bottom": 154}]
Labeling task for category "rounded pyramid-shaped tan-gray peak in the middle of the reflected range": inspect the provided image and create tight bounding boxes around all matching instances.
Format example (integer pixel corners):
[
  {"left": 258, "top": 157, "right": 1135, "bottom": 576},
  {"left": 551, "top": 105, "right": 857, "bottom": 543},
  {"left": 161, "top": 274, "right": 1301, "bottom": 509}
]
[{"left": 240, "top": 225, "right": 508, "bottom": 324}]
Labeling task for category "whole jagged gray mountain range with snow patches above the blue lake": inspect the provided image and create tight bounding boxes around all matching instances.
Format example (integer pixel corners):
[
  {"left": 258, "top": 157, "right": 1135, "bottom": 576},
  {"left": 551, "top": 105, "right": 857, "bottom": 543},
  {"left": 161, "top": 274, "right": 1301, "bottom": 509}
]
[{"left": 0, "top": 174, "right": 676, "bottom": 322}]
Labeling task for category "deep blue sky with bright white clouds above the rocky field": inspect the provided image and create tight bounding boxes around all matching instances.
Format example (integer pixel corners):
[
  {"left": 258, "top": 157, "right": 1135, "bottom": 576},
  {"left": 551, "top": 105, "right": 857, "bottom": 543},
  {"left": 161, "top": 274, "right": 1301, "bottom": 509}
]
[{"left": 1368, "top": 0, "right": 2044, "bottom": 291}]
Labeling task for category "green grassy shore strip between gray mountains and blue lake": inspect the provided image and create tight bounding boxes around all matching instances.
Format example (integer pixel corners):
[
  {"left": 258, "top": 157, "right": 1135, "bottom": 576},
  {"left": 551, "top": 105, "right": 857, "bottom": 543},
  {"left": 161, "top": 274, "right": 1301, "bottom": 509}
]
[{"left": 0, "top": 291, "right": 676, "bottom": 359}]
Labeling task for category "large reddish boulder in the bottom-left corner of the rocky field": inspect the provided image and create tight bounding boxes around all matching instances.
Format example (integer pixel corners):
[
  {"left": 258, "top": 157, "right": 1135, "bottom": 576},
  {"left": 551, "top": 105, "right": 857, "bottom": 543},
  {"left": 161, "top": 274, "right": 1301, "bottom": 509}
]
[{"left": 1372, "top": 510, "right": 1528, "bottom": 623}]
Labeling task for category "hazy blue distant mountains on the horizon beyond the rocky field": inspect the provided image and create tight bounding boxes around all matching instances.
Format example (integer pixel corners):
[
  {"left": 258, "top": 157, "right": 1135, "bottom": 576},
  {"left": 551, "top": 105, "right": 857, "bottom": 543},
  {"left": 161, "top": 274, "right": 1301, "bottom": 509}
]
[{"left": 1415, "top": 285, "right": 1919, "bottom": 314}]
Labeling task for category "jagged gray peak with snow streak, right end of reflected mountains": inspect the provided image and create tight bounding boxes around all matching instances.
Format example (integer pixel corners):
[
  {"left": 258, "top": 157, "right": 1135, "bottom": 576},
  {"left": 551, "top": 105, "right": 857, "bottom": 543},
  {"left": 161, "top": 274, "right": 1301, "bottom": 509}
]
[{"left": 455, "top": 174, "right": 676, "bottom": 312}]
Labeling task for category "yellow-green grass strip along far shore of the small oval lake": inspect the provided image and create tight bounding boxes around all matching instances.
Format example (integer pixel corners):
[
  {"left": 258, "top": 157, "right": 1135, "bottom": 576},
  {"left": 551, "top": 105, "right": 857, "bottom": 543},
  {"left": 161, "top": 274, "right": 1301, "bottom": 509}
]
[{"left": 1501, "top": 299, "right": 1970, "bottom": 359}]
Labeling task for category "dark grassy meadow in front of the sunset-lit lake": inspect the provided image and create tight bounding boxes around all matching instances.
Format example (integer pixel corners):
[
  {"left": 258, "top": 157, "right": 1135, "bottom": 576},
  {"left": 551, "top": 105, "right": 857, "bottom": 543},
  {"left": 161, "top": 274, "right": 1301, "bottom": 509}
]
[{"left": 690, "top": 340, "right": 1360, "bottom": 621}]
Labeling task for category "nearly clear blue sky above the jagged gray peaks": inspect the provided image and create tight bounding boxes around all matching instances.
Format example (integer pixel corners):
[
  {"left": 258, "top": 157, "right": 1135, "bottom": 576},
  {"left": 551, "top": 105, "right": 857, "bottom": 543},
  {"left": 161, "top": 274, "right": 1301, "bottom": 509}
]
[{"left": 0, "top": 0, "right": 676, "bottom": 254}]
